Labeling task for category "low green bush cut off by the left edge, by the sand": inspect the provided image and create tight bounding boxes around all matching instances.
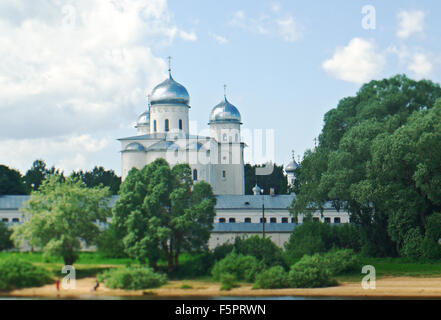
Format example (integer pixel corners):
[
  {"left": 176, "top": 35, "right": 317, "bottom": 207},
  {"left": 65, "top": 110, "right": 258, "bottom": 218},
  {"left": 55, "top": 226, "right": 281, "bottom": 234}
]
[{"left": 0, "top": 257, "right": 52, "bottom": 291}]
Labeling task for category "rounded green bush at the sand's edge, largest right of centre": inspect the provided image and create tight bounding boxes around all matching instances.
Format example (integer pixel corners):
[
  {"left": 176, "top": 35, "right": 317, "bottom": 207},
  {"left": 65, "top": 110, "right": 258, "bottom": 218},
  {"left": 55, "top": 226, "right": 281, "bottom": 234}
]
[{"left": 288, "top": 254, "right": 337, "bottom": 288}]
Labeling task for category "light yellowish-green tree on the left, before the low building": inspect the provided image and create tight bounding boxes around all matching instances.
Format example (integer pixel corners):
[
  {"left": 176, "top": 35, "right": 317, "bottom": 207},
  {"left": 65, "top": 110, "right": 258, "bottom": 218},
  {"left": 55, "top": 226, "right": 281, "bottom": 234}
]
[{"left": 13, "top": 175, "right": 110, "bottom": 265}]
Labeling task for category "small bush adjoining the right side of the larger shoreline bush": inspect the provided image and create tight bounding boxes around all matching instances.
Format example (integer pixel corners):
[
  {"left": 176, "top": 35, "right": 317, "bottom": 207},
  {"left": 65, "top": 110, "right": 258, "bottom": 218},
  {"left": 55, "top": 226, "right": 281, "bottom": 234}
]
[{"left": 324, "top": 249, "right": 360, "bottom": 275}]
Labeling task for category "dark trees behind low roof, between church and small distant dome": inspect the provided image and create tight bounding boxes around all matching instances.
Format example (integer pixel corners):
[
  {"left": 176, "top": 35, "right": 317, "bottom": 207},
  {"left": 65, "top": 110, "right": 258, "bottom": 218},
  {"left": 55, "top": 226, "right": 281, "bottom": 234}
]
[{"left": 245, "top": 163, "right": 289, "bottom": 194}]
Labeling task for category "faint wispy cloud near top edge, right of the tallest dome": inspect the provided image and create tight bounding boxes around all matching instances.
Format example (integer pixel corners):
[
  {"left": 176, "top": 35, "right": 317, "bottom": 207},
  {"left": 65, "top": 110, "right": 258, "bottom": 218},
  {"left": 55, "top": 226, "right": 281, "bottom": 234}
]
[{"left": 230, "top": 4, "right": 303, "bottom": 42}]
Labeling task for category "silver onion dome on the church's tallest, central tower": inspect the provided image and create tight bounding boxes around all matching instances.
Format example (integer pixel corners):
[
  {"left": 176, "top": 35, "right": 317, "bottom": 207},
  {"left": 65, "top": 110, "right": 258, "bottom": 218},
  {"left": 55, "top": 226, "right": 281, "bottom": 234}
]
[{"left": 150, "top": 74, "right": 190, "bottom": 105}]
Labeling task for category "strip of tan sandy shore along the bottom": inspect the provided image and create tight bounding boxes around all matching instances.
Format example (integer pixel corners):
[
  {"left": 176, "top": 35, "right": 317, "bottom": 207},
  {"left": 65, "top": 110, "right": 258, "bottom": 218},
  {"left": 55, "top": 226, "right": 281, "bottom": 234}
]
[{"left": 0, "top": 277, "right": 441, "bottom": 299}]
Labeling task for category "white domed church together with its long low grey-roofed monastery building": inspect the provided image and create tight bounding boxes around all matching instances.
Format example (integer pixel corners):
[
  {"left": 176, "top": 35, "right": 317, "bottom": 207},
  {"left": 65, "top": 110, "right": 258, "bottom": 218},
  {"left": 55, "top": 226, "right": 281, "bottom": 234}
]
[{"left": 0, "top": 64, "right": 349, "bottom": 249}]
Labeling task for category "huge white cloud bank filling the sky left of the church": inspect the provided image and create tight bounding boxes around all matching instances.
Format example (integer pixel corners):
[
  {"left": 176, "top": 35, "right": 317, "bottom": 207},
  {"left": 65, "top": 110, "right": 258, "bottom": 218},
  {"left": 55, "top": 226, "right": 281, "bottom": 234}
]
[{"left": 0, "top": 0, "right": 197, "bottom": 170}]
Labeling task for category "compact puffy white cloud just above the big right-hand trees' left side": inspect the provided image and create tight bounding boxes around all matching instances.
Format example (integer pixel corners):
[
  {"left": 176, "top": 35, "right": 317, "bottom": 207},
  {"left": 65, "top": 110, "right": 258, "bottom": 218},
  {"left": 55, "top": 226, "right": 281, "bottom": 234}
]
[{"left": 322, "top": 38, "right": 386, "bottom": 84}]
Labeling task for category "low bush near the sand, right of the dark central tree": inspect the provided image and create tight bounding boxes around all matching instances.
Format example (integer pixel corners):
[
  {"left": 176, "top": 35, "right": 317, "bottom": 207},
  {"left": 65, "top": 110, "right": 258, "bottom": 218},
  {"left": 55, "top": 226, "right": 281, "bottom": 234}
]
[{"left": 211, "top": 251, "right": 264, "bottom": 282}]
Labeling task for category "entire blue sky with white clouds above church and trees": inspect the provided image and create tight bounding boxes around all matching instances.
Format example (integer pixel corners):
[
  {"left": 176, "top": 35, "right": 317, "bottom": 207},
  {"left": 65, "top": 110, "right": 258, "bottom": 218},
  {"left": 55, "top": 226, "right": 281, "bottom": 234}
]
[{"left": 0, "top": 0, "right": 441, "bottom": 173}]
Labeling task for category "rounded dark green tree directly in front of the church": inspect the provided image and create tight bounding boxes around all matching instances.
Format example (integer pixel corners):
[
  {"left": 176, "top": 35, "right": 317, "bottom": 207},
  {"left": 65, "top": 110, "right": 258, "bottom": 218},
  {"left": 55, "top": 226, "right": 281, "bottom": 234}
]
[{"left": 112, "top": 159, "right": 216, "bottom": 273}]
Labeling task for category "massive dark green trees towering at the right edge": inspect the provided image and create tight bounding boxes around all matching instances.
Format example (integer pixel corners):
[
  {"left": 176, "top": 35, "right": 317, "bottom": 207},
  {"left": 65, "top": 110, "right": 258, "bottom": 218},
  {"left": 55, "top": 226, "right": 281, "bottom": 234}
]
[{"left": 292, "top": 76, "right": 441, "bottom": 257}]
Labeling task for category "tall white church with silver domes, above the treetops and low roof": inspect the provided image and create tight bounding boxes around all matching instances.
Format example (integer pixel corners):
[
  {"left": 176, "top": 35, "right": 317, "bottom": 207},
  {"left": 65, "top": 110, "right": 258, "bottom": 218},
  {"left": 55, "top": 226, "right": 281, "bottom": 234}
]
[{"left": 119, "top": 69, "right": 245, "bottom": 195}]
